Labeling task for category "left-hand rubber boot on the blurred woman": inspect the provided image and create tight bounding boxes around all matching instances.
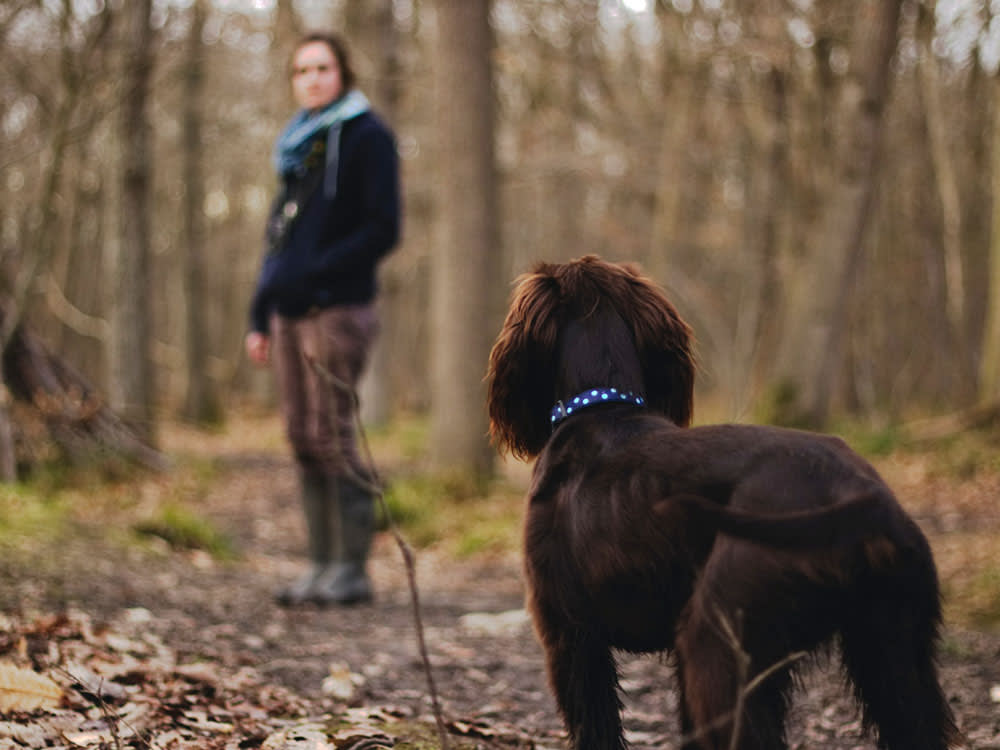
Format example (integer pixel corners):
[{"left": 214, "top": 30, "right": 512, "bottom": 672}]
[{"left": 275, "top": 469, "right": 341, "bottom": 607}]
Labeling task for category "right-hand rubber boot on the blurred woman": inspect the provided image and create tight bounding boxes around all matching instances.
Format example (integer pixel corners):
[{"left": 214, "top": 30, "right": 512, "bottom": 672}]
[{"left": 312, "top": 479, "right": 375, "bottom": 606}]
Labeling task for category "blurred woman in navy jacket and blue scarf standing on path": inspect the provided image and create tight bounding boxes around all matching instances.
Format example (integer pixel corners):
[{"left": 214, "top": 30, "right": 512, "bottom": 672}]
[{"left": 246, "top": 33, "right": 400, "bottom": 606}]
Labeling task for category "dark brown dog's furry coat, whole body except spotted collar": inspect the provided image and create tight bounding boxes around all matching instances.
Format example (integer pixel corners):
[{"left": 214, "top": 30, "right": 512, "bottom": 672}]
[{"left": 488, "top": 256, "right": 959, "bottom": 750}]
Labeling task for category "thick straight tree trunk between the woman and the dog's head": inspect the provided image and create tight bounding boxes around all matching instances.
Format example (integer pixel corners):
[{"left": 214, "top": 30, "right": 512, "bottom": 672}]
[{"left": 430, "top": 0, "right": 499, "bottom": 475}]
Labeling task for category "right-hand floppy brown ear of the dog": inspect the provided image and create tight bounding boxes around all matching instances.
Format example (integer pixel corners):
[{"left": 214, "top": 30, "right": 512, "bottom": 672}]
[{"left": 616, "top": 265, "right": 695, "bottom": 427}]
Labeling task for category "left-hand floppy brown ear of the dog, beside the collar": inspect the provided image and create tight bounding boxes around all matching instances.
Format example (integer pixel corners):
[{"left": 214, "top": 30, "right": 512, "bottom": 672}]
[{"left": 486, "top": 265, "right": 559, "bottom": 458}]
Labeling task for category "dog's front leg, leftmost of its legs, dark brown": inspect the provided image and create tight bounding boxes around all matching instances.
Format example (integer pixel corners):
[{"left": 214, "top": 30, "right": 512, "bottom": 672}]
[{"left": 543, "top": 629, "right": 626, "bottom": 750}]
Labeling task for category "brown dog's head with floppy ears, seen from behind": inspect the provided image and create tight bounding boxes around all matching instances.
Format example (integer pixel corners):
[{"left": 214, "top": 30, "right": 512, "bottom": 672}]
[{"left": 487, "top": 255, "right": 695, "bottom": 458}]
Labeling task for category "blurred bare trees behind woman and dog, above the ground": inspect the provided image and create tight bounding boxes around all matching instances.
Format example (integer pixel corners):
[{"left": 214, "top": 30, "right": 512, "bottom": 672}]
[{"left": 0, "top": 0, "right": 1000, "bottom": 472}]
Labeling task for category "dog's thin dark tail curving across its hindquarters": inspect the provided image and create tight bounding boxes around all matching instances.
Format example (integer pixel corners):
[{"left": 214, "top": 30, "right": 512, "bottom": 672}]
[{"left": 667, "top": 490, "right": 895, "bottom": 548}]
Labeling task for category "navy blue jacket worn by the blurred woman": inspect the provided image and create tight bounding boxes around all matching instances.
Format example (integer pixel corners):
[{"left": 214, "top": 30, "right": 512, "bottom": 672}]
[{"left": 250, "top": 111, "right": 400, "bottom": 333}]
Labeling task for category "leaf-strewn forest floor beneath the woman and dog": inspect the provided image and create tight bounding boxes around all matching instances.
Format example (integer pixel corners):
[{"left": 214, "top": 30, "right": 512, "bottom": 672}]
[{"left": 0, "top": 418, "right": 1000, "bottom": 750}]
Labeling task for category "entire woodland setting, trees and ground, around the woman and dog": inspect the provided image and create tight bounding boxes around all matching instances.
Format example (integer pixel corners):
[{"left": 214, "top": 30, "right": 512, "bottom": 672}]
[{"left": 0, "top": 0, "right": 1000, "bottom": 750}]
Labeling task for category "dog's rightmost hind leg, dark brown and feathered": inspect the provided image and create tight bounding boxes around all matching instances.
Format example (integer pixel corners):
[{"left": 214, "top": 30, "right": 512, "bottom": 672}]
[{"left": 841, "top": 546, "right": 960, "bottom": 750}]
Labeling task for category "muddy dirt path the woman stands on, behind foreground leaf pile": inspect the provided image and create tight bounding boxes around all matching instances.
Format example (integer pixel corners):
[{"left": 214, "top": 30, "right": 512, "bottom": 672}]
[{"left": 0, "top": 426, "right": 1000, "bottom": 750}]
